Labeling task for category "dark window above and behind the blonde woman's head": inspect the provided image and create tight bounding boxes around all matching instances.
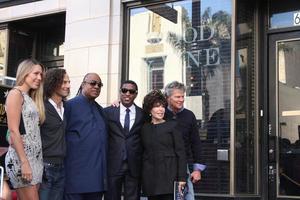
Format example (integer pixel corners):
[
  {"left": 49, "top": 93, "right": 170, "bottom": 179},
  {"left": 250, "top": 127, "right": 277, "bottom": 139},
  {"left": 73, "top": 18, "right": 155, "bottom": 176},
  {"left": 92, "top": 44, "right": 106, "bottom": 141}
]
[{"left": 7, "top": 12, "right": 66, "bottom": 77}]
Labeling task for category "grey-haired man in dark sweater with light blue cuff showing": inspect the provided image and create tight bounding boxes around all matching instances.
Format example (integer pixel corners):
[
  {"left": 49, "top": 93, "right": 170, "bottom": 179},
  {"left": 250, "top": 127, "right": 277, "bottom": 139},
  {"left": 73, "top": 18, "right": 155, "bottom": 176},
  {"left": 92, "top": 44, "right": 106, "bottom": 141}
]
[{"left": 164, "top": 81, "right": 205, "bottom": 200}]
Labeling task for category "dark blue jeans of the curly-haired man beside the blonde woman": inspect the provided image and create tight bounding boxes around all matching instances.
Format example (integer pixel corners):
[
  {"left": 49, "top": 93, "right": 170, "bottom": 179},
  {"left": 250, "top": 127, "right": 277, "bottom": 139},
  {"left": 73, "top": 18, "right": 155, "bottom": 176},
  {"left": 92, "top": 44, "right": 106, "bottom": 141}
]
[{"left": 39, "top": 162, "right": 65, "bottom": 200}]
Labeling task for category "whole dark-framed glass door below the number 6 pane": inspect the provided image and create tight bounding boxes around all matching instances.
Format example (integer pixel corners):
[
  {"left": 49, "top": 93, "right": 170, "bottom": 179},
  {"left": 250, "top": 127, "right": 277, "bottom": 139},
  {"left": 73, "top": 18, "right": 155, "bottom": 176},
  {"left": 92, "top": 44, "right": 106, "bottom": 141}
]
[{"left": 268, "top": 31, "right": 300, "bottom": 200}]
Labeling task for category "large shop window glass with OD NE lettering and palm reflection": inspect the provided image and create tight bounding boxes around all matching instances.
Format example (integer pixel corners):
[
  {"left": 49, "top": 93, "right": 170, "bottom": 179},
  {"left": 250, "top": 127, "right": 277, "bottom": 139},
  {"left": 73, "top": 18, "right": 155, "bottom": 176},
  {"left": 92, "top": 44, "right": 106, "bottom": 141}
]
[{"left": 128, "top": 0, "right": 232, "bottom": 194}]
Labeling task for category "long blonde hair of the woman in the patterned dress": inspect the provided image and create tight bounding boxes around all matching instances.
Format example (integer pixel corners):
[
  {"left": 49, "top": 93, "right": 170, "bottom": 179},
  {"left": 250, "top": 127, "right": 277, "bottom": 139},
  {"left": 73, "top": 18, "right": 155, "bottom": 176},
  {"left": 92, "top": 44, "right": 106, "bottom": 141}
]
[{"left": 16, "top": 59, "right": 46, "bottom": 124}]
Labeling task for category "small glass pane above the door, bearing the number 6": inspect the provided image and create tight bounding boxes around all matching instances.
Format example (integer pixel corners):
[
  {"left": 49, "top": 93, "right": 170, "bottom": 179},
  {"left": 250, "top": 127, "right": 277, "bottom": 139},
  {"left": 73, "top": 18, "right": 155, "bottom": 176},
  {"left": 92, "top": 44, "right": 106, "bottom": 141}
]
[{"left": 270, "top": 0, "right": 300, "bottom": 29}]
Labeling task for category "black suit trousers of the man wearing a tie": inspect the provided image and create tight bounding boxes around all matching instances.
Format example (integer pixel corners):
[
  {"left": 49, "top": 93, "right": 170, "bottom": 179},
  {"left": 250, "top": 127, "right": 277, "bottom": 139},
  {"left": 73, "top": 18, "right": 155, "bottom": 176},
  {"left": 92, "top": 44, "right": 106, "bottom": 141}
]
[{"left": 104, "top": 161, "right": 141, "bottom": 200}]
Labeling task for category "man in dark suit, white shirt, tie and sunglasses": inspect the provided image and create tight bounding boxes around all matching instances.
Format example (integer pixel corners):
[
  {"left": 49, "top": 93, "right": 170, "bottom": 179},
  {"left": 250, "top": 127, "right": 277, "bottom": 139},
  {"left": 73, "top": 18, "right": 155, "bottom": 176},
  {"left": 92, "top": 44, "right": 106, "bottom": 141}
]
[{"left": 104, "top": 80, "right": 144, "bottom": 200}]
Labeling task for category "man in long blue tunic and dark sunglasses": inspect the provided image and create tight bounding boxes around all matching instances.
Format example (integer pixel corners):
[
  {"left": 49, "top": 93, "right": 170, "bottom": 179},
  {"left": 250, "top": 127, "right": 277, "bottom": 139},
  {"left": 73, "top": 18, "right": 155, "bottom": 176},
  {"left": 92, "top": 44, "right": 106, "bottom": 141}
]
[{"left": 64, "top": 73, "right": 107, "bottom": 200}]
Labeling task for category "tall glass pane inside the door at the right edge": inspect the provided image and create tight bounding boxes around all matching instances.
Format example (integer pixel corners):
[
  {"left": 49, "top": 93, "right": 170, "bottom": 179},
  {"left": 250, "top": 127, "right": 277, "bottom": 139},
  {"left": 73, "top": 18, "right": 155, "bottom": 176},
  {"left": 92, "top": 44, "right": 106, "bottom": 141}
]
[{"left": 277, "top": 40, "right": 300, "bottom": 196}]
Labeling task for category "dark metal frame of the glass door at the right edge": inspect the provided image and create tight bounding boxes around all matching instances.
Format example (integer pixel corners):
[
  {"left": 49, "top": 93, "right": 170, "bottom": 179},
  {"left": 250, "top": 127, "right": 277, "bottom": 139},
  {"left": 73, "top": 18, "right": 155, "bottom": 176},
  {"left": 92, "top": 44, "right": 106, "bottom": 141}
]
[{"left": 267, "top": 31, "right": 300, "bottom": 200}]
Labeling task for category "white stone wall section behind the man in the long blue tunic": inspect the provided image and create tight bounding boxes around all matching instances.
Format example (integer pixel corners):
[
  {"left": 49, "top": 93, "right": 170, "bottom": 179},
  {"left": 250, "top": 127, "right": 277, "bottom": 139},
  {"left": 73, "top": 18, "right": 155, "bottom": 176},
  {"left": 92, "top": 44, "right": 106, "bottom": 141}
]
[{"left": 65, "top": 0, "right": 122, "bottom": 106}]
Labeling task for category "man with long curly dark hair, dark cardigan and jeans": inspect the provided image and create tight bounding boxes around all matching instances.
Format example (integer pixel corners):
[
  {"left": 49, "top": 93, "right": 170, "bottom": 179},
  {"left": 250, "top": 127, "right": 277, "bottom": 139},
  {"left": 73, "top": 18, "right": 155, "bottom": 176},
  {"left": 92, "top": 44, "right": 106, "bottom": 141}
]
[{"left": 39, "top": 69, "right": 70, "bottom": 200}]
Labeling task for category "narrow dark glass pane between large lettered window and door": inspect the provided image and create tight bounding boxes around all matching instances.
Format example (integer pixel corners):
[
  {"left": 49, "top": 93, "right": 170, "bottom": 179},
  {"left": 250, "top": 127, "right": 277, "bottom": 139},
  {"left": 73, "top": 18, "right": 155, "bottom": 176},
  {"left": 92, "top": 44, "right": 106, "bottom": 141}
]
[{"left": 235, "top": 0, "right": 258, "bottom": 194}]
